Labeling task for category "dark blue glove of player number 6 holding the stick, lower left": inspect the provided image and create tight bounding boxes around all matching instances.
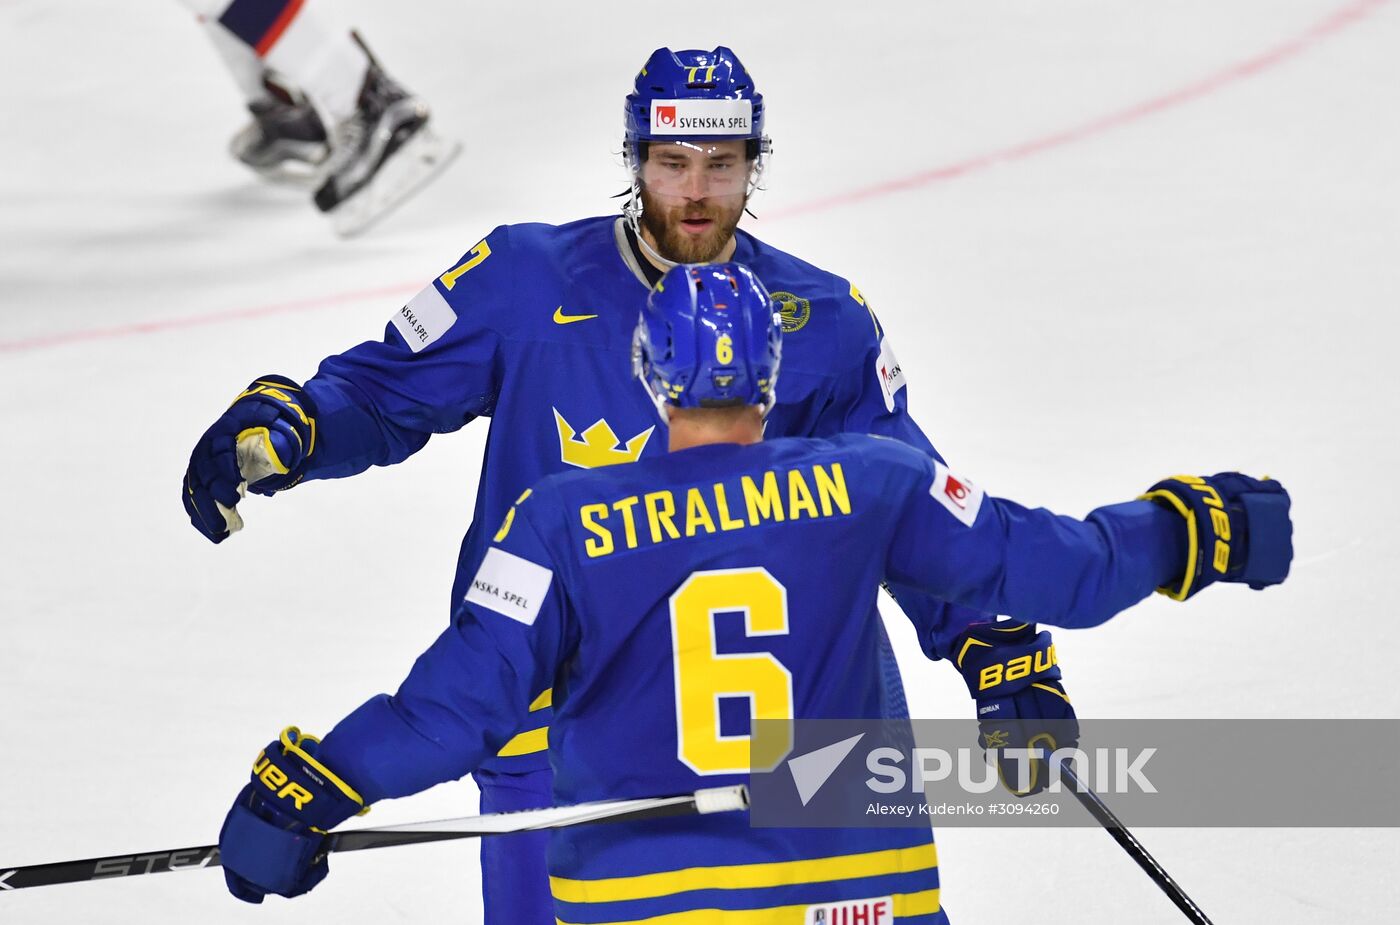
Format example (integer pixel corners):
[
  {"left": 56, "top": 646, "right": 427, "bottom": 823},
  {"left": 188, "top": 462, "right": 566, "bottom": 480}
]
[{"left": 218, "top": 726, "right": 370, "bottom": 903}]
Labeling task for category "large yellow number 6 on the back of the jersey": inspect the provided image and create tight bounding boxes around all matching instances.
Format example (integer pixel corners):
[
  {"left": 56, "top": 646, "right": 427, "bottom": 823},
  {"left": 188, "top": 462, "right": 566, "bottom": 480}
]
[{"left": 671, "top": 568, "right": 792, "bottom": 774}]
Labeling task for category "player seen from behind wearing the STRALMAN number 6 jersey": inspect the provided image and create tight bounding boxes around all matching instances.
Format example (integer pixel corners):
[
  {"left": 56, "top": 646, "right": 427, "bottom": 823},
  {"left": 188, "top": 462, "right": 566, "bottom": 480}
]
[{"left": 212, "top": 263, "right": 1292, "bottom": 925}]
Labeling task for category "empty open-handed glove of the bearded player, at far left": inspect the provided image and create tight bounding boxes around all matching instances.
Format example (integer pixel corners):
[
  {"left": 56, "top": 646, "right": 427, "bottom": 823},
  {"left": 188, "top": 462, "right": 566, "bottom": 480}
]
[{"left": 181, "top": 376, "right": 316, "bottom": 543}]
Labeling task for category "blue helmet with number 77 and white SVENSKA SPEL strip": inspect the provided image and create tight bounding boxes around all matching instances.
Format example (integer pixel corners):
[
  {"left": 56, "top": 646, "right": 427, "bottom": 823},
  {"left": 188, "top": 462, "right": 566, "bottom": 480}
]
[{"left": 624, "top": 45, "right": 767, "bottom": 153}]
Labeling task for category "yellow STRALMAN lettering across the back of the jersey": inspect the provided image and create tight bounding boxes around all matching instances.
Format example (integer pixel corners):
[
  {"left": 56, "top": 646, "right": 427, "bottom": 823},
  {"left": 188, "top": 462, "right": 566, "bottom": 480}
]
[{"left": 578, "top": 463, "right": 851, "bottom": 558}]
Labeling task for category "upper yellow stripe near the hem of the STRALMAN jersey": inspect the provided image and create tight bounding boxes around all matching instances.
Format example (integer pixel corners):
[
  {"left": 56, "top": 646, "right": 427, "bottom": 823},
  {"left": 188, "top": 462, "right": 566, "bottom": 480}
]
[{"left": 549, "top": 844, "right": 938, "bottom": 901}]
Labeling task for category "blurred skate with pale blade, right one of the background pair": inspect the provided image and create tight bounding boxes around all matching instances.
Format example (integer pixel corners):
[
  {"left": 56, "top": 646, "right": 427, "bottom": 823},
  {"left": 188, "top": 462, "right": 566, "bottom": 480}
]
[{"left": 315, "top": 37, "right": 462, "bottom": 236}]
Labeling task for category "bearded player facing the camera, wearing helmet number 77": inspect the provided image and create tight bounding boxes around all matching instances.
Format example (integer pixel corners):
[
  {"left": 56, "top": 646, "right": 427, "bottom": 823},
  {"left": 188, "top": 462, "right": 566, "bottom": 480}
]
[{"left": 182, "top": 48, "right": 1074, "bottom": 925}]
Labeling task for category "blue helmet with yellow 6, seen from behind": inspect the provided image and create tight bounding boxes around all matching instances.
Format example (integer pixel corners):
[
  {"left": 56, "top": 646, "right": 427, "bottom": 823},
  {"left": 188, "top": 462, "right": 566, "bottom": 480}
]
[{"left": 631, "top": 262, "right": 783, "bottom": 421}]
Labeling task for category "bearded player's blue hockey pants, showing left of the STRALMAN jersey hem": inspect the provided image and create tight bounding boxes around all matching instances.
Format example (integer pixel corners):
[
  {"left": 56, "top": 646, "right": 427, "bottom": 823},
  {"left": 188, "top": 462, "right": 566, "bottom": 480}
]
[{"left": 472, "top": 768, "right": 554, "bottom": 925}]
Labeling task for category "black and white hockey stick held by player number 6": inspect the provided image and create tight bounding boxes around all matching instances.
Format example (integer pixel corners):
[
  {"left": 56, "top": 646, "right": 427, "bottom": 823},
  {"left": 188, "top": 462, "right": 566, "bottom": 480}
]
[{"left": 0, "top": 784, "right": 749, "bottom": 893}]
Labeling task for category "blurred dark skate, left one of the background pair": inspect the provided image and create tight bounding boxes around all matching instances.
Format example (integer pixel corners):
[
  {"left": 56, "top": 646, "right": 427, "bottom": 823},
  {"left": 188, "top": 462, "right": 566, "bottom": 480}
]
[{"left": 228, "top": 80, "right": 330, "bottom": 188}]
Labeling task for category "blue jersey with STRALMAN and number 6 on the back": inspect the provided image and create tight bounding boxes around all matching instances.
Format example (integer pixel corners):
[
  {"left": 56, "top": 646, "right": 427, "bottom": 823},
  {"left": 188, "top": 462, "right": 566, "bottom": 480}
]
[{"left": 322, "top": 433, "right": 1186, "bottom": 925}]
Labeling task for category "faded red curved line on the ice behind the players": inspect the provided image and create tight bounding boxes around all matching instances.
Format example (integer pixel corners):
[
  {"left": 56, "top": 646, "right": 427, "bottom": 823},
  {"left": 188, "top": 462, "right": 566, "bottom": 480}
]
[{"left": 0, "top": 0, "right": 1390, "bottom": 353}]
